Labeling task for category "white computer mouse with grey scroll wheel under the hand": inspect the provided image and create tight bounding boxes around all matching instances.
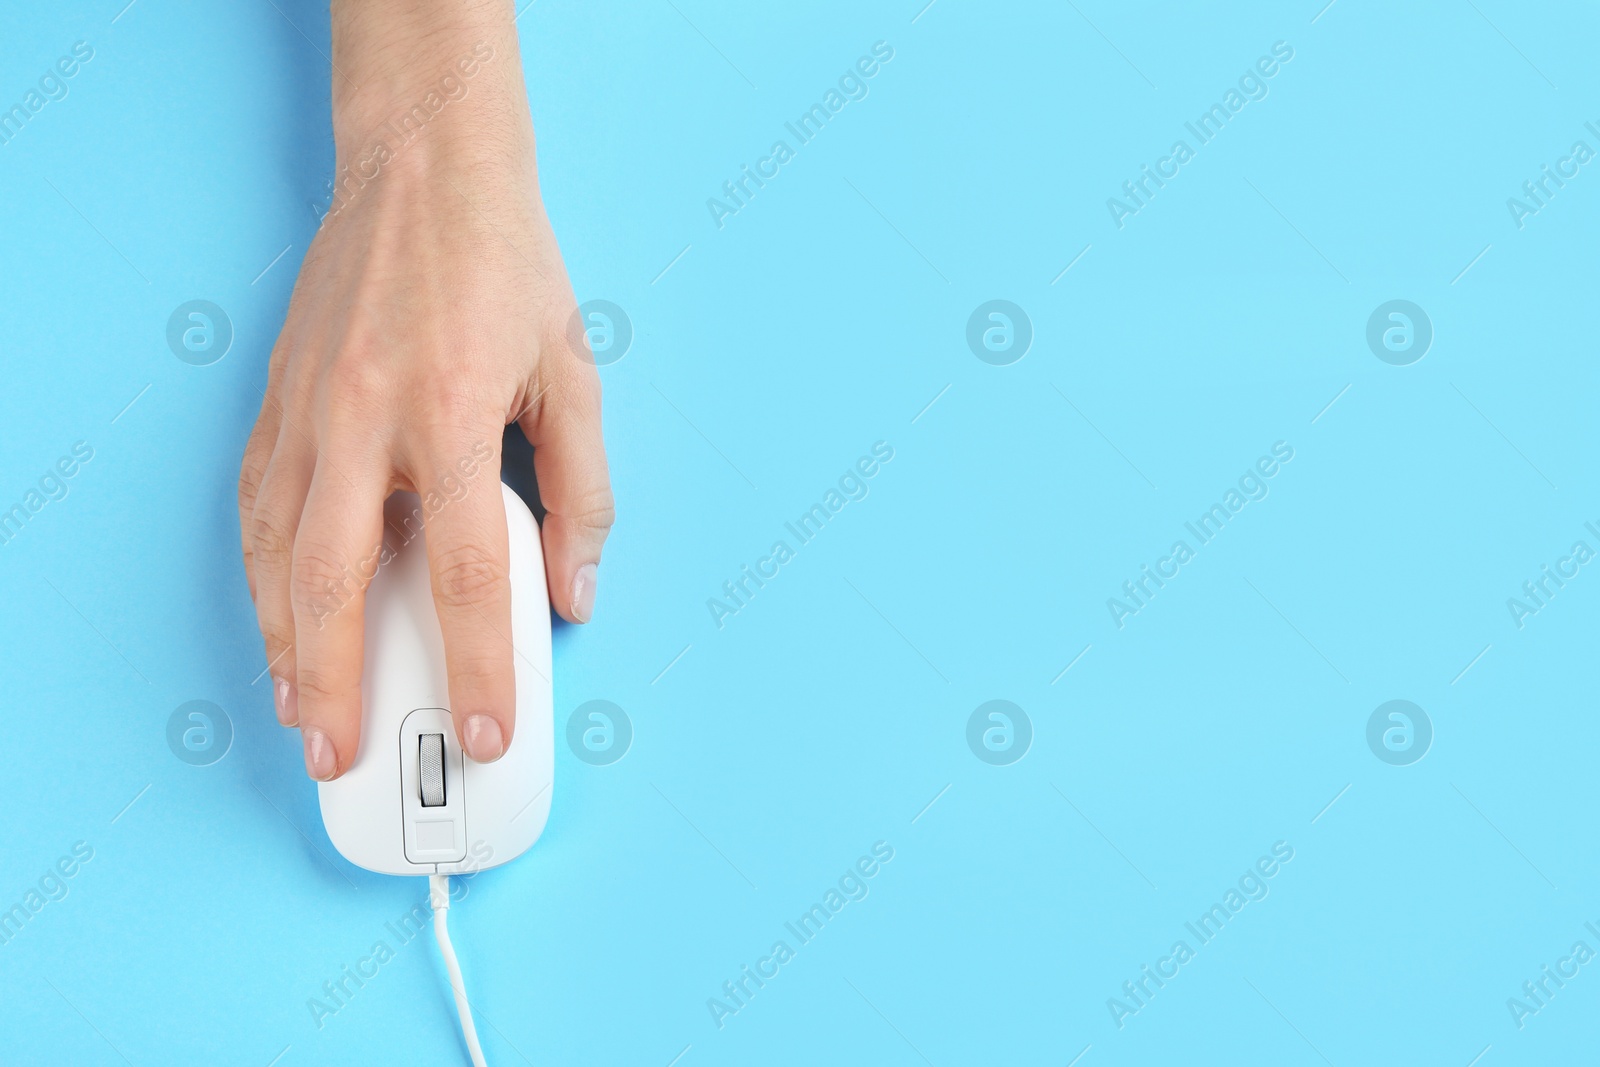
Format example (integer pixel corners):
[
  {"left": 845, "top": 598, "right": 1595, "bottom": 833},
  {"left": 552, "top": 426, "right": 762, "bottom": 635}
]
[{"left": 317, "top": 485, "right": 555, "bottom": 875}]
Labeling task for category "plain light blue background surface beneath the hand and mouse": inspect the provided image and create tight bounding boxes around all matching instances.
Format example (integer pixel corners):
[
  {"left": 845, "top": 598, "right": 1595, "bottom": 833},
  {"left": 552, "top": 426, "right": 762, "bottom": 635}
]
[{"left": 0, "top": 0, "right": 1600, "bottom": 1067}]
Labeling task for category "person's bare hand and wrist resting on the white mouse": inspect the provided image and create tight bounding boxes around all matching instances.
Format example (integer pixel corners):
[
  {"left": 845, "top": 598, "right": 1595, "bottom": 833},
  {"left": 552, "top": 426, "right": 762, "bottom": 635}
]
[{"left": 238, "top": 0, "right": 613, "bottom": 781}]
